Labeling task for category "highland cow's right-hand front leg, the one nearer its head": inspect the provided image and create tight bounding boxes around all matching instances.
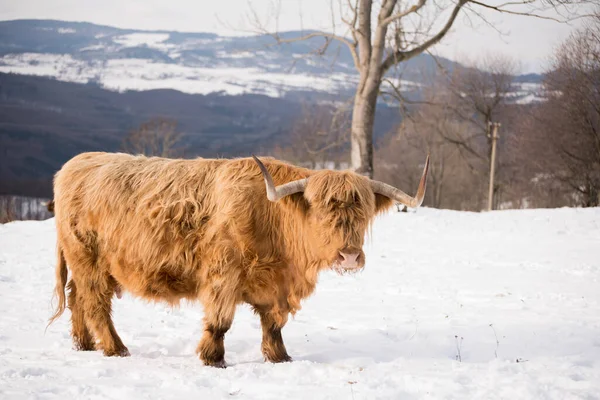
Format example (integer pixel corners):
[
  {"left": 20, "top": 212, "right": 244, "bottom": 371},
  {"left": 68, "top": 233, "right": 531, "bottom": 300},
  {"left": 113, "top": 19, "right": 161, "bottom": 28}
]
[{"left": 257, "top": 308, "right": 292, "bottom": 363}]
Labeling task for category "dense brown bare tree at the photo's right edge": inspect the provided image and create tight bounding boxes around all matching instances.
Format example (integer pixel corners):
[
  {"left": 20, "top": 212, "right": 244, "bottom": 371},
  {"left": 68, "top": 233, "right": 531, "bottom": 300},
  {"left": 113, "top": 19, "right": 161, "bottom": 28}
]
[{"left": 519, "top": 10, "right": 600, "bottom": 207}]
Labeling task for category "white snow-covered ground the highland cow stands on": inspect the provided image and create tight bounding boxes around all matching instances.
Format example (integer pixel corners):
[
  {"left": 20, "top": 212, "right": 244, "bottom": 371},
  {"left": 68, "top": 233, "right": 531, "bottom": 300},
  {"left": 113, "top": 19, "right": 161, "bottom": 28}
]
[{"left": 0, "top": 209, "right": 600, "bottom": 399}]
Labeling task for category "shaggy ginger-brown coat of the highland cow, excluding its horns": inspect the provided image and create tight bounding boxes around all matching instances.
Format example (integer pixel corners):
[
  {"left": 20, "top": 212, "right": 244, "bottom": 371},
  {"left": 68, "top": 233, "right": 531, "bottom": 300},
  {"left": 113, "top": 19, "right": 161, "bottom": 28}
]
[{"left": 51, "top": 153, "right": 418, "bottom": 366}]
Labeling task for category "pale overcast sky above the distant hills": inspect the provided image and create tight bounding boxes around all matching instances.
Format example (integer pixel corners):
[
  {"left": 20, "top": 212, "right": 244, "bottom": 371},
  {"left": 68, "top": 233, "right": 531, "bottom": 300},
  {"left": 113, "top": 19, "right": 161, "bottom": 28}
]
[{"left": 0, "top": 0, "right": 592, "bottom": 73}]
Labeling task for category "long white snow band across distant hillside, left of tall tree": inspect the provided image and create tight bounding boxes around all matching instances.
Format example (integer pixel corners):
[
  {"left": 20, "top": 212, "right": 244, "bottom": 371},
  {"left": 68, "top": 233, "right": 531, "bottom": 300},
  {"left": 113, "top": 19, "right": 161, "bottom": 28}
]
[{"left": 0, "top": 52, "right": 358, "bottom": 97}]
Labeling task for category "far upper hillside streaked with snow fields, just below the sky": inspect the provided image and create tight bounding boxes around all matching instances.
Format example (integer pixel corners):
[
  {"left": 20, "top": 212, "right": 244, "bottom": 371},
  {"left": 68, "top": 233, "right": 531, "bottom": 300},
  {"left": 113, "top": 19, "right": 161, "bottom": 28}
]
[{"left": 0, "top": 20, "right": 539, "bottom": 101}]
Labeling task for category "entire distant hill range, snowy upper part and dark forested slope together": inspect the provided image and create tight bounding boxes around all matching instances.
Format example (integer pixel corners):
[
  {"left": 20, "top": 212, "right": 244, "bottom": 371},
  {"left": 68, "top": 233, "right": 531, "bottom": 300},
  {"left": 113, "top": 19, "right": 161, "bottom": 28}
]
[{"left": 0, "top": 20, "right": 541, "bottom": 197}]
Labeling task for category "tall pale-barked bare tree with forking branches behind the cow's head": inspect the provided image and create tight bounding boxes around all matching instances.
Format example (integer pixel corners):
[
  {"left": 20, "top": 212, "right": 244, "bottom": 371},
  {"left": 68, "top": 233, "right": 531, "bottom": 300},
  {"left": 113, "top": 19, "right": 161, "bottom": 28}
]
[{"left": 252, "top": 0, "right": 589, "bottom": 177}]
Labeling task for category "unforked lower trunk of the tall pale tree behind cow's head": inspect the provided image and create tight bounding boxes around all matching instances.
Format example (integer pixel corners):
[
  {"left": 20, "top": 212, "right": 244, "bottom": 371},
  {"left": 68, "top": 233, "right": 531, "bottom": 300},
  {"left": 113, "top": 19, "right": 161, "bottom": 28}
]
[{"left": 351, "top": 90, "right": 378, "bottom": 179}]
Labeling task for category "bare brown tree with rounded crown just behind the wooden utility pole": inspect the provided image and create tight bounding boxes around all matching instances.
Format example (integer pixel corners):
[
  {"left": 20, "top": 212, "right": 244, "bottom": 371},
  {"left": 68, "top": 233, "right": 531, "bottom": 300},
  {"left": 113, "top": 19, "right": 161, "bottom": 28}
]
[{"left": 385, "top": 55, "right": 516, "bottom": 209}]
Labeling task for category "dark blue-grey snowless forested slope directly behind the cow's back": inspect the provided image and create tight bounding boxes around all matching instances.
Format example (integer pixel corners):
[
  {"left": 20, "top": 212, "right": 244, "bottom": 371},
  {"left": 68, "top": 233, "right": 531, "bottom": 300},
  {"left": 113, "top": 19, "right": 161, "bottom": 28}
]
[{"left": 0, "top": 73, "right": 399, "bottom": 197}]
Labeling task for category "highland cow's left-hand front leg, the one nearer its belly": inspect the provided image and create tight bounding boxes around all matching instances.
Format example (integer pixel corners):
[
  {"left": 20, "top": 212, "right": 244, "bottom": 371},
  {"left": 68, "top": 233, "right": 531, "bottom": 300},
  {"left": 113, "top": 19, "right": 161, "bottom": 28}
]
[{"left": 196, "top": 304, "right": 235, "bottom": 368}]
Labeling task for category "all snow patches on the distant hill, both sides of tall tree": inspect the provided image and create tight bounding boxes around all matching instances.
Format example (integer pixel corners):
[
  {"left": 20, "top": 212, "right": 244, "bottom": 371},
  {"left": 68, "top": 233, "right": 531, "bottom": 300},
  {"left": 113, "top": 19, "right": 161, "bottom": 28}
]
[{"left": 0, "top": 28, "right": 544, "bottom": 100}]
